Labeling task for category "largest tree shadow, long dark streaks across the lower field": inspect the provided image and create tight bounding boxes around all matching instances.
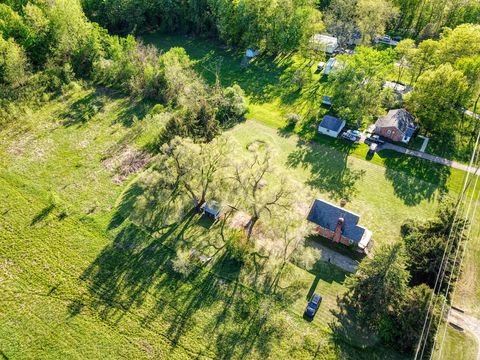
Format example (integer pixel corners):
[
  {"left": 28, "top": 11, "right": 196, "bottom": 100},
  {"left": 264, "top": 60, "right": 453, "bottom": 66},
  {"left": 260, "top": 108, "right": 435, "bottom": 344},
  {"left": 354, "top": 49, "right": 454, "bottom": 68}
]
[{"left": 73, "top": 214, "right": 286, "bottom": 358}]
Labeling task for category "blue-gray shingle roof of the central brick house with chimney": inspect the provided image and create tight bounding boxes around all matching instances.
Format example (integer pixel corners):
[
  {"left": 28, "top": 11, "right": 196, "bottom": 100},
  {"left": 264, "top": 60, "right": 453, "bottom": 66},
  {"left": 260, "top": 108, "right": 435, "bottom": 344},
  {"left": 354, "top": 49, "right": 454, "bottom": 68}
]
[{"left": 307, "top": 199, "right": 365, "bottom": 243}]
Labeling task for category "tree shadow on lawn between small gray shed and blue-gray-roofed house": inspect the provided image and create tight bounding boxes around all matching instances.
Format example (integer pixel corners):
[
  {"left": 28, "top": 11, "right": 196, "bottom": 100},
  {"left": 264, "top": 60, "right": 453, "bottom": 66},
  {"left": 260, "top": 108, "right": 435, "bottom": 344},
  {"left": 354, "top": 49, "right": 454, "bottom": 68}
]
[{"left": 287, "top": 140, "right": 365, "bottom": 201}]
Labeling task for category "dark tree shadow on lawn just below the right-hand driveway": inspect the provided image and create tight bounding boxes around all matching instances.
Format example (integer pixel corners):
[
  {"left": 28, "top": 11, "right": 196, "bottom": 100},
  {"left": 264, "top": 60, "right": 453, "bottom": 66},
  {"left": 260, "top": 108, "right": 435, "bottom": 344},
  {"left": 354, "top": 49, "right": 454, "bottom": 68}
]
[{"left": 378, "top": 150, "right": 450, "bottom": 206}]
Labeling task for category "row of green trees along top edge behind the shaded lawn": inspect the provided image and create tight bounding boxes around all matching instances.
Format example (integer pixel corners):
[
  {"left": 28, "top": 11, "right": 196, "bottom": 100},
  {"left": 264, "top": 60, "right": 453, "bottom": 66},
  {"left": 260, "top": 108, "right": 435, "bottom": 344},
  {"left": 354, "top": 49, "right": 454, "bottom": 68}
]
[{"left": 82, "top": 0, "right": 322, "bottom": 53}]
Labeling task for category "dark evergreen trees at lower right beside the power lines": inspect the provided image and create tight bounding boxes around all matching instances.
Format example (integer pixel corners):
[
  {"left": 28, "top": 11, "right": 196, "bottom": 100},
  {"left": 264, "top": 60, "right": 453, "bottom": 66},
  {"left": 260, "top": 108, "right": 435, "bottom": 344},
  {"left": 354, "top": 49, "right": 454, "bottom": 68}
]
[{"left": 339, "top": 199, "right": 469, "bottom": 353}]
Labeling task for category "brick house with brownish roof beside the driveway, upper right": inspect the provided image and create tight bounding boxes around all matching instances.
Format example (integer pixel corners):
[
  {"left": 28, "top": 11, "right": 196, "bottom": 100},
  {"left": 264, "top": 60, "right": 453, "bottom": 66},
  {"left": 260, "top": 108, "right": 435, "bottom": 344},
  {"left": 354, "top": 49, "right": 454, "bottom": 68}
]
[{"left": 374, "top": 109, "right": 417, "bottom": 144}]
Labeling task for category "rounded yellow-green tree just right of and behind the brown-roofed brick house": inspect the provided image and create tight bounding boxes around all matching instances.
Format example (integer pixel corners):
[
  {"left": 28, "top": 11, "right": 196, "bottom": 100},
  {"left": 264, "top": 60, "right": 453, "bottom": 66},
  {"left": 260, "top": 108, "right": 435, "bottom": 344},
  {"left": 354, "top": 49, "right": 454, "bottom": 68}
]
[{"left": 407, "top": 64, "right": 468, "bottom": 134}]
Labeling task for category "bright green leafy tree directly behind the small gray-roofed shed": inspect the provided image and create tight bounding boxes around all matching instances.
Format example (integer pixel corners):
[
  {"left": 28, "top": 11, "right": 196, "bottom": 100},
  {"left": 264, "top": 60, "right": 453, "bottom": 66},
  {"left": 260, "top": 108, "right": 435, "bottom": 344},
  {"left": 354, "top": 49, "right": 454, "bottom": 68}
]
[{"left": 330, "top": 47, "right": 394, "bottom": 125}]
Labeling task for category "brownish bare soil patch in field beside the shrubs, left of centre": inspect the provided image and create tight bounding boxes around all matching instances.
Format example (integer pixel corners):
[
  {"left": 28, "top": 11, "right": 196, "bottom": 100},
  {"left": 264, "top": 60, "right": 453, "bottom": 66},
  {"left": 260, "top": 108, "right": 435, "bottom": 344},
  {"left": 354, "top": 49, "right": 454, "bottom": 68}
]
[{"left": 103, "top": 145, "right": 152, "bottom": 185}]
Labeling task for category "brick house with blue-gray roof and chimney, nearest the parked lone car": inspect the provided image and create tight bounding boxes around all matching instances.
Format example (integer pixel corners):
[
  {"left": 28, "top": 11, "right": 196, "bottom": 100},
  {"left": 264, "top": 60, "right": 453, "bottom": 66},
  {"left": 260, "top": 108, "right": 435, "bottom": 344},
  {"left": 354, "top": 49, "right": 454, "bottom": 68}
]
[{"left": 307, "top": 199, "right": 372, "bottom": 253}]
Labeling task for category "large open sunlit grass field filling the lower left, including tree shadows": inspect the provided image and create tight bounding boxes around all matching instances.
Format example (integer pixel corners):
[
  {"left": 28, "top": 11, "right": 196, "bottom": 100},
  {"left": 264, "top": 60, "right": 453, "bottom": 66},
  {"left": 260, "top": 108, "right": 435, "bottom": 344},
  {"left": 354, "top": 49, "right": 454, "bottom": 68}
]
[{"left": 0, "top": 89, "right": 412, "bottom": 359}]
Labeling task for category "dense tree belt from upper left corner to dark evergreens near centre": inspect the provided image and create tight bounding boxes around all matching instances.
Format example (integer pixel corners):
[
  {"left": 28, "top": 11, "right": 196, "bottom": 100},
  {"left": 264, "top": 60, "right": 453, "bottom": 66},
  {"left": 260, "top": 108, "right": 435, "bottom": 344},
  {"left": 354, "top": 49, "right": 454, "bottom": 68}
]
[{"left": 0, "top": 0, "right": 246, "bottom": 142}]
